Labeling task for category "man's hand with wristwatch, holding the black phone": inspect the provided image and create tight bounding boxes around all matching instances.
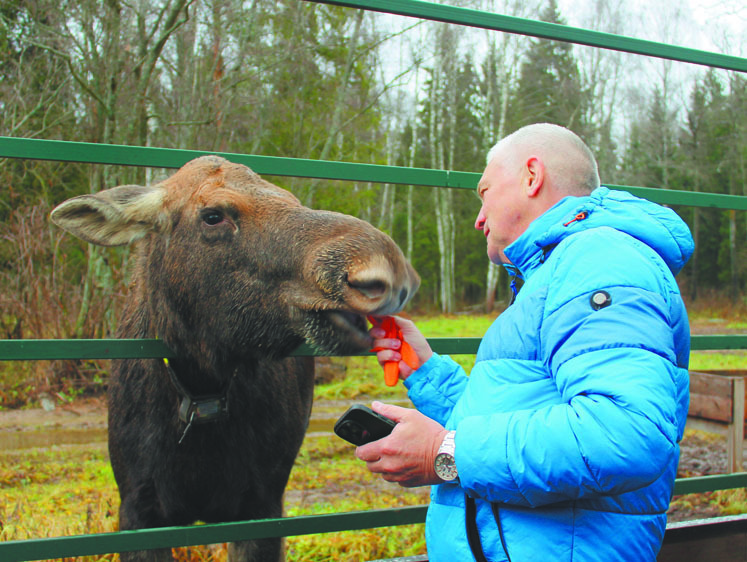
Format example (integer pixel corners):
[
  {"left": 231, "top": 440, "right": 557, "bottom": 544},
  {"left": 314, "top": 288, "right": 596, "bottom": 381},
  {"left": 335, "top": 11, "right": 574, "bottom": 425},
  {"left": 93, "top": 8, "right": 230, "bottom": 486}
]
[{"left": 355, "top": 398, "right": 446, "bottom": 488}]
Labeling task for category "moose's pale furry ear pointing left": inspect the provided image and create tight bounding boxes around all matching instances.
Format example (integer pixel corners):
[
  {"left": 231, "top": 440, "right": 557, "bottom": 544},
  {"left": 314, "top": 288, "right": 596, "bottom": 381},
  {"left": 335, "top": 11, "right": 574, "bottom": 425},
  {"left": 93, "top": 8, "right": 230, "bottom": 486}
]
[{"left": 50, "top": 185, "right": 164, "bottom": 246}]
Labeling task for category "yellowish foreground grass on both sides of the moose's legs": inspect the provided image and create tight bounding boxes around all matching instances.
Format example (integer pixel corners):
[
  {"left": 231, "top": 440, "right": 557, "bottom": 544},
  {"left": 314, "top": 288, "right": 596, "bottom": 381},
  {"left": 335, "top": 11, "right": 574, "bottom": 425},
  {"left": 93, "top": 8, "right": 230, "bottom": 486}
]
[{"left": 0, "top": 434, "right": 428, "bottom": 562}]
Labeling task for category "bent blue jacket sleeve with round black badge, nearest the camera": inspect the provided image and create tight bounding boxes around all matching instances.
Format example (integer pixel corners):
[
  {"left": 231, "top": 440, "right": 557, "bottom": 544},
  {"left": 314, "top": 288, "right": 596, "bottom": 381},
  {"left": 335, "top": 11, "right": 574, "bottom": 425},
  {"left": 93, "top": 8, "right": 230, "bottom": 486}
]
[{"left": 455, "top": 230, "right": 689, "bottom": 506}]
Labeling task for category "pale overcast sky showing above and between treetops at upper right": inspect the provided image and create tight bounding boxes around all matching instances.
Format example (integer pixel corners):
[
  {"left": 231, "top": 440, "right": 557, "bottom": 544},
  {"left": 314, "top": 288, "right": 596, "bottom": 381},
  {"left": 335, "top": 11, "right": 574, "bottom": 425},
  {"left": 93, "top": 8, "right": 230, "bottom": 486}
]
[{"left": 376, "top": 0, "right": 747, "bottom": 153}]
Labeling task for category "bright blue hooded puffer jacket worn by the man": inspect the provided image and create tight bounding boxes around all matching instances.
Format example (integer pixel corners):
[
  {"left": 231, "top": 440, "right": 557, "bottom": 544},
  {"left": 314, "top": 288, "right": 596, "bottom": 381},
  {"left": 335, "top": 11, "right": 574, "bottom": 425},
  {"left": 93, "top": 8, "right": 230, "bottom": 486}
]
[{"left": 405, "top": 187, "right": 693, "bottom": 562}]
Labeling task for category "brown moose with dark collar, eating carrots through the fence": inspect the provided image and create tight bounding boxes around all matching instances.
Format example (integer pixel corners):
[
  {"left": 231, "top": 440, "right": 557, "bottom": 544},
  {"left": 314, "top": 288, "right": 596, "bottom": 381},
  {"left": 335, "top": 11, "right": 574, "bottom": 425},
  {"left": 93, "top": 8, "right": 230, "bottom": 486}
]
[{"left": 51, "top": 155, "right": 420, "bottom": 562}]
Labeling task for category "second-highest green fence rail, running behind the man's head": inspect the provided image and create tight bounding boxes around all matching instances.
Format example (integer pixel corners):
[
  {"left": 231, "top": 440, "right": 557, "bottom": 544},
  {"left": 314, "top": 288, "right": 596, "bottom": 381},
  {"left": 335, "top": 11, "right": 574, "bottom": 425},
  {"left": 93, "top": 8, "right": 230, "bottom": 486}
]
[{"left": 0, "top": 137, "right": 747, "bottom": 211}]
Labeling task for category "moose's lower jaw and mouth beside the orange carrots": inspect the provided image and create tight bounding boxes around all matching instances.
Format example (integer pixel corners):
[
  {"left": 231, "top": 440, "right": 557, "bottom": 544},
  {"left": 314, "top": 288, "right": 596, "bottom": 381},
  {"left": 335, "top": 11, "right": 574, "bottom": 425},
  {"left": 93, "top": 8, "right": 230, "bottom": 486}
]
[{"left": 304, "top": 310, "right": 373, "bottom": 355}]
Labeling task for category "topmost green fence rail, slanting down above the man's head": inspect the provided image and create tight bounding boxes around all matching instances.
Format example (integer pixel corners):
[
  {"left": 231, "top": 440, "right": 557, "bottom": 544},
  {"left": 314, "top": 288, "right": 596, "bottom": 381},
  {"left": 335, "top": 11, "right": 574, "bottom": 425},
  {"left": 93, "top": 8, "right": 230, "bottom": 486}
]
[{"left": 307, "top": 0, "right": 747, "bottom": 72}]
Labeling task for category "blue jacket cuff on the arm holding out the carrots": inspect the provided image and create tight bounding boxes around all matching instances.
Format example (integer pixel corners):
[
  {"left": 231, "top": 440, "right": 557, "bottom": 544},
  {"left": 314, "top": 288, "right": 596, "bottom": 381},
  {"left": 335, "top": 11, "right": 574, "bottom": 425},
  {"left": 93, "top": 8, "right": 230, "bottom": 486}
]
[{"left": 404, "top": 353, "right": 467, "bottom": 426}]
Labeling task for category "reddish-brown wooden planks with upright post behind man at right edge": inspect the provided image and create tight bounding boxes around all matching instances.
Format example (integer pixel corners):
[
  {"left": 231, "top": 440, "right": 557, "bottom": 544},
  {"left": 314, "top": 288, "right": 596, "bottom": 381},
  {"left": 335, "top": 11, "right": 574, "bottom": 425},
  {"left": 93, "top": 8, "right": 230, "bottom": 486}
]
[{"left": 687, "top": 370, "right": 747, "bottom": 472}]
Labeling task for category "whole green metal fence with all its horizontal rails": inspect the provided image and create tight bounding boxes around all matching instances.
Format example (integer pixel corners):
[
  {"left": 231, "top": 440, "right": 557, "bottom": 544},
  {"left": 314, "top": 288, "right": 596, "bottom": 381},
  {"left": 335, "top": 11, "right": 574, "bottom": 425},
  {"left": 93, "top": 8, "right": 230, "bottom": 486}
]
[{"left": 0, "top": 0, "right": 747, "bottom": 562}]
